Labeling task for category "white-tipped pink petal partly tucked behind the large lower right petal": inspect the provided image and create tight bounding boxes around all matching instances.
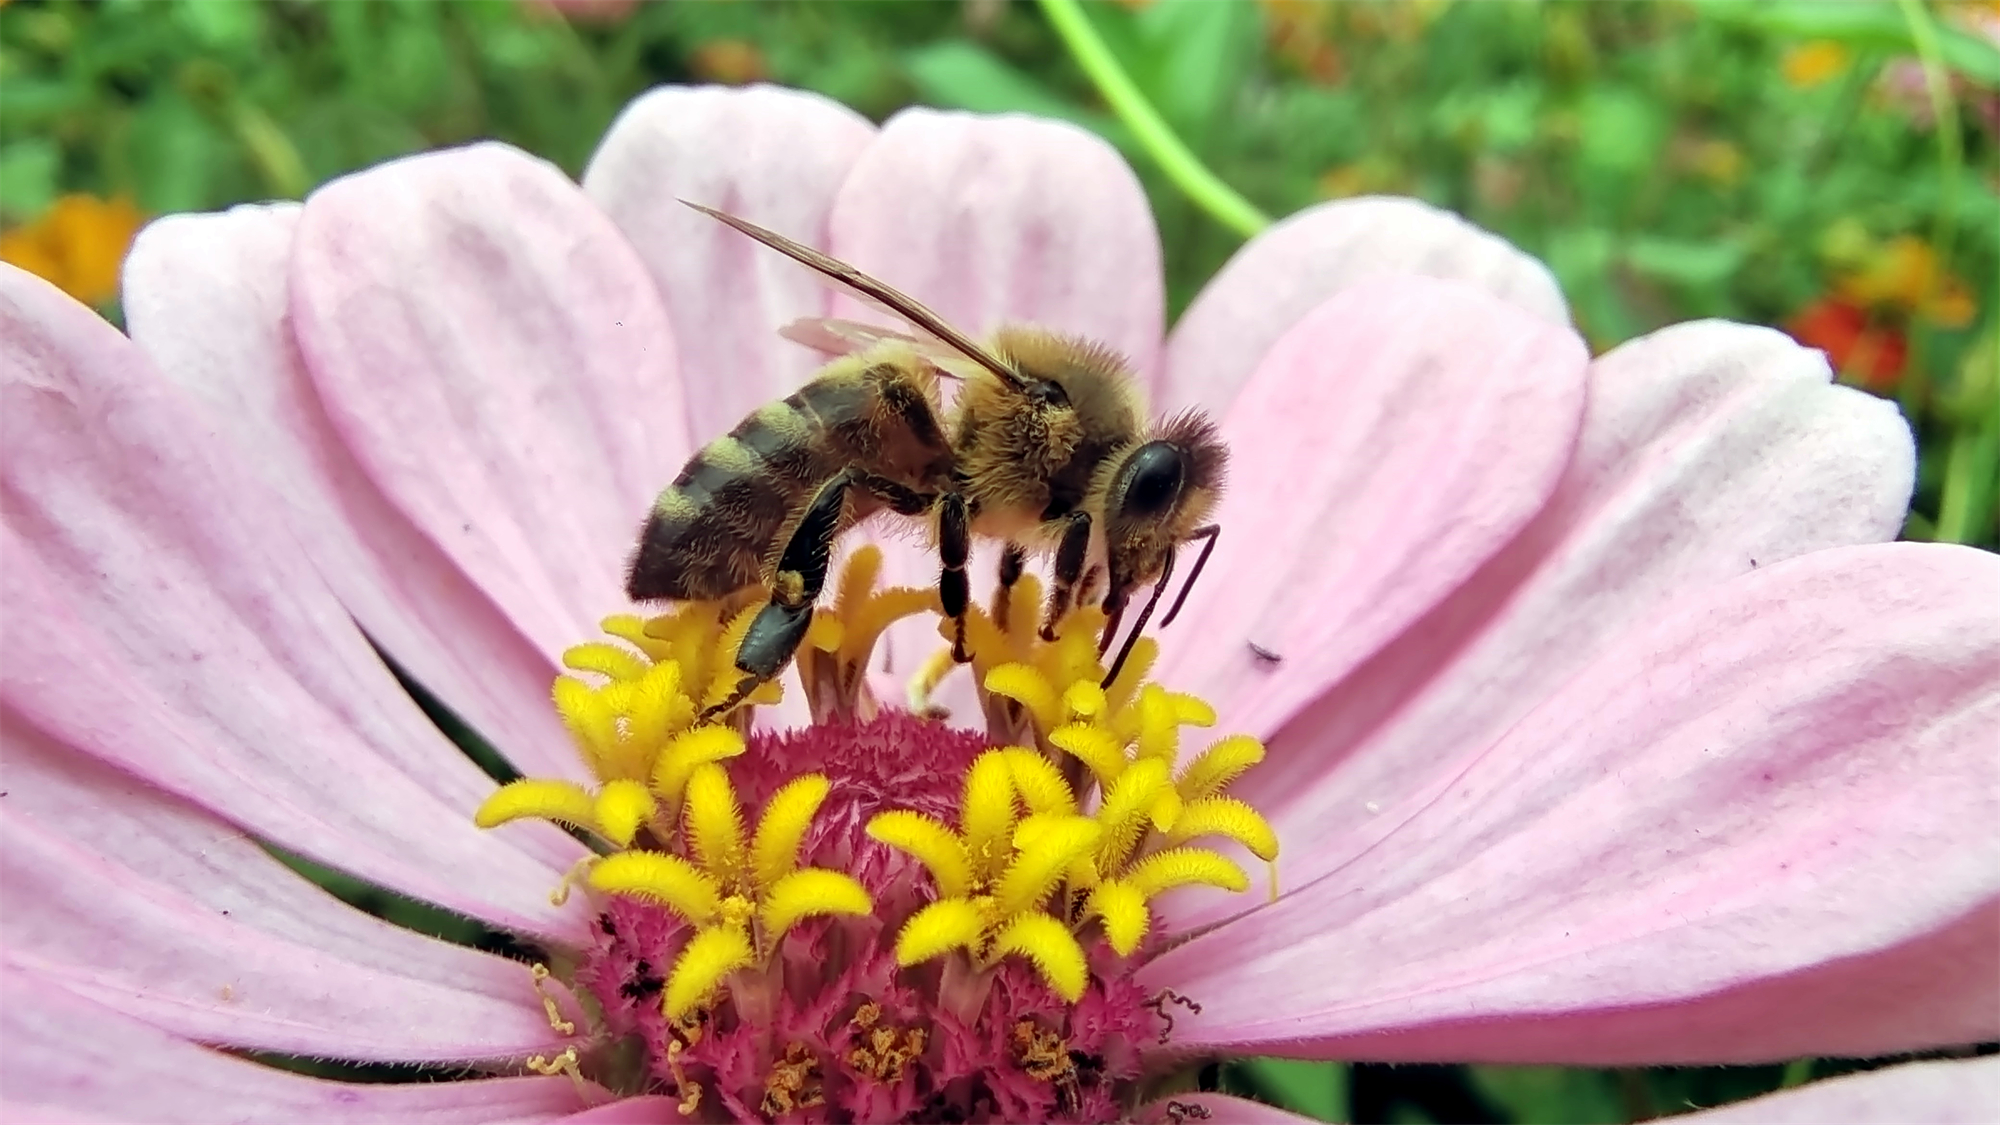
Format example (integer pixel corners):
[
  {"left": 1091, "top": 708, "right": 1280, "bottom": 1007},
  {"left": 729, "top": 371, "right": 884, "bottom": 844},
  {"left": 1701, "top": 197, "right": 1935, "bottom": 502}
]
[{"left": 1196, "top": 322, "right": 1914, "bottom": 896}]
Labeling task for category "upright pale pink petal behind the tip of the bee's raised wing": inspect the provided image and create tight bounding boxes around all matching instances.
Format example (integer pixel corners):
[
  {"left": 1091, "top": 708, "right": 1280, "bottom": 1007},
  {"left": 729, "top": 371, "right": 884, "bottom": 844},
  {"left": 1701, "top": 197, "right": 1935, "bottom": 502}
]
[{"left": 584, "top": 86, "right": 874, "bottom": 436}]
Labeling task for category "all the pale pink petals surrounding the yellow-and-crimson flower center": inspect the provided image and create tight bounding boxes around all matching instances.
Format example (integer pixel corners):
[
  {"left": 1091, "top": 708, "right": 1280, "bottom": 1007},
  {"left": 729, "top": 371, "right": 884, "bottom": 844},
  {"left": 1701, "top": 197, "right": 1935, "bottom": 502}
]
[{"left": 0, "top": 88, "right": 2000, "bottom": 1121}]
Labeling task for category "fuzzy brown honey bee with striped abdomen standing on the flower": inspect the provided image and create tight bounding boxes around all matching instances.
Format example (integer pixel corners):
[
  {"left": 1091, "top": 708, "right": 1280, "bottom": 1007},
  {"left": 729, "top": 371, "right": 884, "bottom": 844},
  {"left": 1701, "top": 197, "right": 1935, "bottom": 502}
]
[{"left": 626, "top": 200, "right": 1228, "bottom": 715}]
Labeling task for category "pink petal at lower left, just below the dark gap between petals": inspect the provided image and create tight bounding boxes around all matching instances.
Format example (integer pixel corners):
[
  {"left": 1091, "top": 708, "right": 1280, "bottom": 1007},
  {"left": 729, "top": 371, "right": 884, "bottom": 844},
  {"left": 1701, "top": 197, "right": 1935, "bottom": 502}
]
[{"left": 0, "top": 715, "right": 562, "bottom": 1061}]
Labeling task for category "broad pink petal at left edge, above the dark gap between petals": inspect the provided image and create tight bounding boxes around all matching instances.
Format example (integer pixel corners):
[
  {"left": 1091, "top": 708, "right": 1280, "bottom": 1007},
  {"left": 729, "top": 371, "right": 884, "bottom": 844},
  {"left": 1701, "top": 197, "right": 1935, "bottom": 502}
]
[{"left": 0, "top": 268, "right": 578, "bottom": 935}]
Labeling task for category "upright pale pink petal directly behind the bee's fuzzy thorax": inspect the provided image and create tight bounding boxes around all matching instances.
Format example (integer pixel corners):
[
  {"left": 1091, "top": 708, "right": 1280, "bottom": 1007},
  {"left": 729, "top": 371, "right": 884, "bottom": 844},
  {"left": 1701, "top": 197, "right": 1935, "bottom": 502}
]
[{"left": 828, "top": 108, "right": 1166, "bottom": 684}]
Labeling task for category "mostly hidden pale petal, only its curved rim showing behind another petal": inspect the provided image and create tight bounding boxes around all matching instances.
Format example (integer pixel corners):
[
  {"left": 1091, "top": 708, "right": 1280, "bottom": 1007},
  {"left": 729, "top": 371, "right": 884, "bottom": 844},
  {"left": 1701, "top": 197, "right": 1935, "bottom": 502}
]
[{"left": 1158, "top": 198, "right": 1570, "bottom": 412}]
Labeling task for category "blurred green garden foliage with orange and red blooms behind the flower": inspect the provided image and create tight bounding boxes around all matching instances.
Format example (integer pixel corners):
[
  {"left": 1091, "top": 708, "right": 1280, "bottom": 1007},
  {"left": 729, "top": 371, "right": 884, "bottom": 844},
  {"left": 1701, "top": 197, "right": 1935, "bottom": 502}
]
[{"left": 0, "top": 0, "right": 2000, "bottom": 1121}]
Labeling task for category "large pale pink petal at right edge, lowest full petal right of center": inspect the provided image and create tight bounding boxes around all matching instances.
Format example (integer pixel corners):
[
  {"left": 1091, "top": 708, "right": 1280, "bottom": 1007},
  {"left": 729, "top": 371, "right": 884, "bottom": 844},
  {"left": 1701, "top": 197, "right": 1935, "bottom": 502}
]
[{"left": 1142, "top": 544, "right": 2000, "bottom": 1065}]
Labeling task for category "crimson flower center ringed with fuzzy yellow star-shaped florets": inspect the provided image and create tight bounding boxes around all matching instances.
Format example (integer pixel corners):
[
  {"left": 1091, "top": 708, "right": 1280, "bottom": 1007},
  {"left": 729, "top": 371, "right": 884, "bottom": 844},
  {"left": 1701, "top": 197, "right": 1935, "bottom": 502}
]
[{"left": 476, "top": 546, "right": 1278, "bottom": 1121}]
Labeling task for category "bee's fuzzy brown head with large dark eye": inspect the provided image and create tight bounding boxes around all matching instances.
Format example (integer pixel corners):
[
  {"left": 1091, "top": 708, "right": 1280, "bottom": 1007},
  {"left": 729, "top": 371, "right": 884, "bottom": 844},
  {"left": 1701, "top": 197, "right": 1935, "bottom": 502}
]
[{"left": 1096, "top": 410, "right": 1230, "bottom": 607}]
